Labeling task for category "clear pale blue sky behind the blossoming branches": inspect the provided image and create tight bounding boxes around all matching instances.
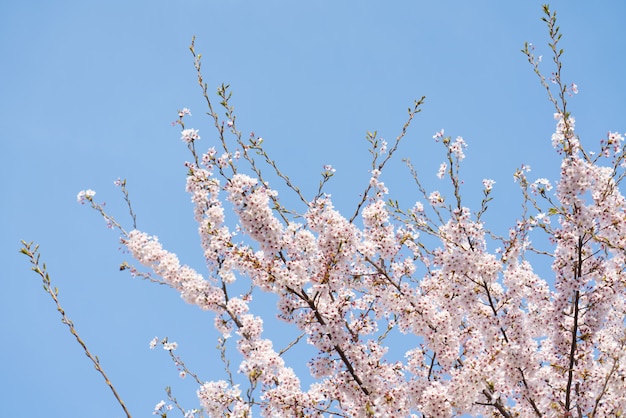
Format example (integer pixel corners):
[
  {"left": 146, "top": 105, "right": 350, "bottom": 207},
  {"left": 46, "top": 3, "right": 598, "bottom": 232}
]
[{"left": 0, "top": 0, "right": 626, "bottom": 418}]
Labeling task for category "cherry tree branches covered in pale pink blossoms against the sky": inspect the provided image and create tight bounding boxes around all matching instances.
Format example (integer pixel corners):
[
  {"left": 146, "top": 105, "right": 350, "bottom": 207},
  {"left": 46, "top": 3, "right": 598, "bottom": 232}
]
[{"left": 22, "top": 6, "right": 626, "bottom": 417}]
